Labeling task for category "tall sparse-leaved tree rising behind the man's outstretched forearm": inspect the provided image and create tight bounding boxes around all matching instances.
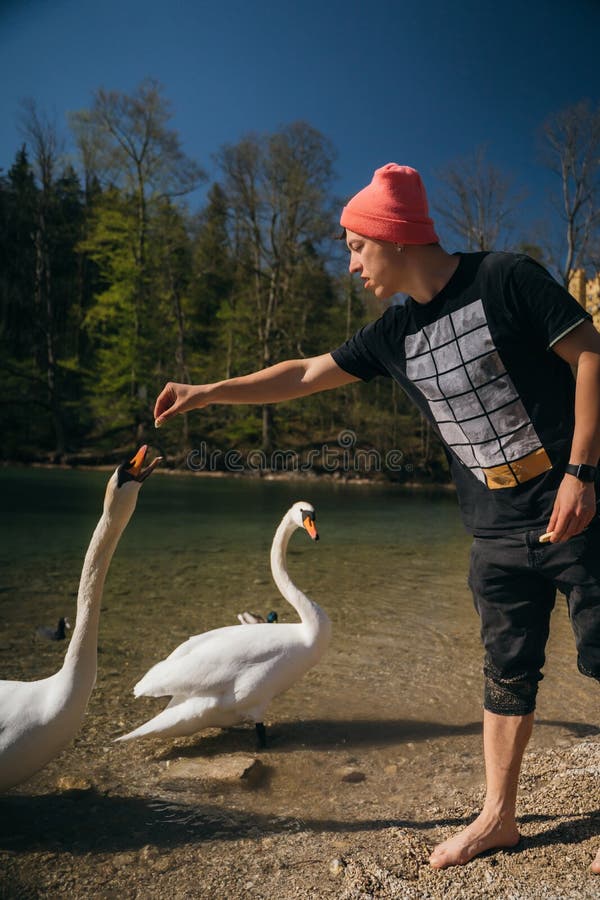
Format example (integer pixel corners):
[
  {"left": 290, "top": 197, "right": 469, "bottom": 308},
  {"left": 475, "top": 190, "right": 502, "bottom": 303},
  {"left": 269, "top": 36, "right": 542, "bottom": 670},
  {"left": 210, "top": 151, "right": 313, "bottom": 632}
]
[{"left": 218, "top": 122, "right": 334, "bottom": 451}]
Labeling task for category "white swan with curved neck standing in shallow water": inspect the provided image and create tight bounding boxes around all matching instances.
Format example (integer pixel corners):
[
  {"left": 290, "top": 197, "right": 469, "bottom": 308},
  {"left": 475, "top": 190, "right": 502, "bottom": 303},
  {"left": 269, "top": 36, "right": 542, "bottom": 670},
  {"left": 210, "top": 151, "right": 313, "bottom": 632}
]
[{"left": 117, "top": 502, "right": 331, "bottom": 746}]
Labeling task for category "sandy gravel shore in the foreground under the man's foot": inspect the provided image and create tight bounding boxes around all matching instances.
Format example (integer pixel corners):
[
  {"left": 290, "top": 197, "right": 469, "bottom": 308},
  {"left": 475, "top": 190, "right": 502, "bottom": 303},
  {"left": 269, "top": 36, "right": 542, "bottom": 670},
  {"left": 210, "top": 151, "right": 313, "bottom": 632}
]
[{"left": 0, "top": 729, "right": 600, "bottom": 900}]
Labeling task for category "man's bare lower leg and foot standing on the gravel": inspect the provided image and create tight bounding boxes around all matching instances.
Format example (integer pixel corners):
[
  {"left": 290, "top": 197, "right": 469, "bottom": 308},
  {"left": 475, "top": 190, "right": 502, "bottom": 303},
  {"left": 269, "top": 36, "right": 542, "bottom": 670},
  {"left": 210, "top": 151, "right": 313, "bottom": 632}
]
[{"left": 429, "top": 709, "right": 532, "bottom": 869}]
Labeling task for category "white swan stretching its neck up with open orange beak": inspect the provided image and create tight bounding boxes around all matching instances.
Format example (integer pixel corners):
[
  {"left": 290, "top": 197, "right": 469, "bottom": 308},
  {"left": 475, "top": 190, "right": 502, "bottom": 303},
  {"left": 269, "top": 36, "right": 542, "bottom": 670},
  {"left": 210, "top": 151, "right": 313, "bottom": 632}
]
[{"left": 0, "top": 446, "right": 160, "bottom": 791}]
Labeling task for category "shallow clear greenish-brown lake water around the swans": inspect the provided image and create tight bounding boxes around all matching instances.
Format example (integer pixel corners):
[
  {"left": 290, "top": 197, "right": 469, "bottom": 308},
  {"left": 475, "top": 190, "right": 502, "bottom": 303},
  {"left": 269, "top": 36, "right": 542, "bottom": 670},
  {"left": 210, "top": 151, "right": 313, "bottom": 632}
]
[{"left": 0, "top": 468, "right": 598, "bottom": 819}]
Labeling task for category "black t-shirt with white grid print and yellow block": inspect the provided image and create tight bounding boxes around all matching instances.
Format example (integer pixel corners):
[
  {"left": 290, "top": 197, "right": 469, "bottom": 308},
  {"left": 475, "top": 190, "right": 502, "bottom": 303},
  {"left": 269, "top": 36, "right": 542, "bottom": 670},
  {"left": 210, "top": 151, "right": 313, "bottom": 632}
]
[{"left": 332, "top": 253, "right": 591, "bottom": 536}]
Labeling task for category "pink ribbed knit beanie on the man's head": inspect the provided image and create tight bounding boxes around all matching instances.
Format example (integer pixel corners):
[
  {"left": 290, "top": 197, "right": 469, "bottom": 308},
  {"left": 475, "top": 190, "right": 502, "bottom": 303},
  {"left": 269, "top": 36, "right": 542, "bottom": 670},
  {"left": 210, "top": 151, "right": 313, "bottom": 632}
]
[{"left": 340, "top": 163, "right": 439, "bottom": 244}]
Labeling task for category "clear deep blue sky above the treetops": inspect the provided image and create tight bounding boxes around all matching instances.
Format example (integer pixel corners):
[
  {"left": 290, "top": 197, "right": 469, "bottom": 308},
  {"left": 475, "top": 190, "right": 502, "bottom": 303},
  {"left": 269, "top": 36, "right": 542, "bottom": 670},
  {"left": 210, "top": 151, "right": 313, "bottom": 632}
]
[{"left": 0, "top": 0, "right": 600, "bottom": 249}]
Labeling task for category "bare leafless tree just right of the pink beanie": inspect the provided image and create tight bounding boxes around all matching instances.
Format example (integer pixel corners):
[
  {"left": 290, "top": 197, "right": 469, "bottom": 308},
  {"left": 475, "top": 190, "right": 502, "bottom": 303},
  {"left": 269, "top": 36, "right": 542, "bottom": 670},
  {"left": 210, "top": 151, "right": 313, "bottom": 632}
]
[{"left": 434, "top": 147, "right": 522, "bottom": 250}]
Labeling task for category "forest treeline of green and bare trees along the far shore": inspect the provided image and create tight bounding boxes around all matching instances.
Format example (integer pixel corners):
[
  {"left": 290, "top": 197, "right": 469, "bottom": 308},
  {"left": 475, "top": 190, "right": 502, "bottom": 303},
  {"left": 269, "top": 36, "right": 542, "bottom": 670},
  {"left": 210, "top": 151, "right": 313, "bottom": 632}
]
[{"left": 0, "top": 80, "right": 598, "bottom": 481}]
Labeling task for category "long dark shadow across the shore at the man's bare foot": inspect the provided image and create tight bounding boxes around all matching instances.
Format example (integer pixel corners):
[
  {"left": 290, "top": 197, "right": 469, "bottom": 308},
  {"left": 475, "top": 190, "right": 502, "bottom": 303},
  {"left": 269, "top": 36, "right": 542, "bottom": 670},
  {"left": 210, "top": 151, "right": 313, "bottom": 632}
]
[{"left": 0, "top": 790, "right": 600, "bottom": 854}]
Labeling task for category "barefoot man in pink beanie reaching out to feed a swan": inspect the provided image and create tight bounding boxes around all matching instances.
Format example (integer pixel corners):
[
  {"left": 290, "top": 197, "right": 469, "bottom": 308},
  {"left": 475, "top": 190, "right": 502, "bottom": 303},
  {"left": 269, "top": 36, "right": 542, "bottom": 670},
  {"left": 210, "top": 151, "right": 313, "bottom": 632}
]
[{"left": 155, "top": 163, "right": 600, "bottom": 874}]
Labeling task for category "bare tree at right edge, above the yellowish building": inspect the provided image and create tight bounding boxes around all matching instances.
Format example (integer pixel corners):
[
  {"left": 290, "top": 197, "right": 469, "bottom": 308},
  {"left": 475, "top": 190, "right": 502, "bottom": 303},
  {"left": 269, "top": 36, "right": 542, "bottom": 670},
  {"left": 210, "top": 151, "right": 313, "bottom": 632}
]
[{"left": 543, "top": 102, "right": 600, "bottom": 286}]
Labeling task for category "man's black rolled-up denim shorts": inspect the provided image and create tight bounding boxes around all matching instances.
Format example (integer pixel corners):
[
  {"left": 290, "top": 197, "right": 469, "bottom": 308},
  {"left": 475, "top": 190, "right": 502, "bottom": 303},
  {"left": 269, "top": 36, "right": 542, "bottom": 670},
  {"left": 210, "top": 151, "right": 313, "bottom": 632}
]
[{"left": 469, "top": 518, "right": 600, "bottom": 706}]
